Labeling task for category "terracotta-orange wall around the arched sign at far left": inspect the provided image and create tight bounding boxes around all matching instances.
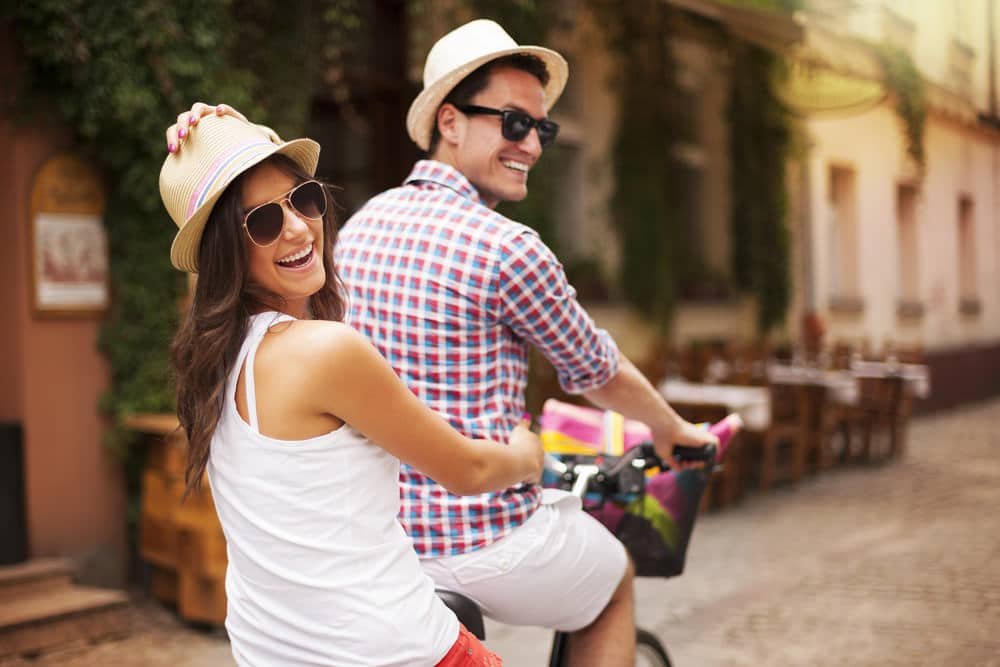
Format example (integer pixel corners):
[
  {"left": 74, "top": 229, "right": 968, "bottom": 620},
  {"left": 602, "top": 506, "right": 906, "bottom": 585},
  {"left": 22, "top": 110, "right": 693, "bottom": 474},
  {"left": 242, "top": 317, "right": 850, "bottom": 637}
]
[{"left": 0, "top": 26, "right": 126, "bottom": 585}]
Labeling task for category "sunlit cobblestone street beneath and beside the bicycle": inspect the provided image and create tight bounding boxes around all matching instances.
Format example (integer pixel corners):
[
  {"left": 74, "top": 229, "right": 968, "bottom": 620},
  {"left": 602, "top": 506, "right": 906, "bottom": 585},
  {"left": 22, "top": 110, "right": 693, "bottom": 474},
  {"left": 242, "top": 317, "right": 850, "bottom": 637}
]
[{"left": 5, "top": 400, "right": 1000, "bottom": 667}]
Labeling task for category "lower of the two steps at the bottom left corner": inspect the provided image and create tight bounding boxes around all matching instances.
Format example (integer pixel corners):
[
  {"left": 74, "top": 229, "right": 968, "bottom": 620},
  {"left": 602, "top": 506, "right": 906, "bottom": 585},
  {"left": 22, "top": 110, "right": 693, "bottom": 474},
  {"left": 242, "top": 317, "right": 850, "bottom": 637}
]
[{"left": 0, "top": 584, "right": 129, "bottom": 659}]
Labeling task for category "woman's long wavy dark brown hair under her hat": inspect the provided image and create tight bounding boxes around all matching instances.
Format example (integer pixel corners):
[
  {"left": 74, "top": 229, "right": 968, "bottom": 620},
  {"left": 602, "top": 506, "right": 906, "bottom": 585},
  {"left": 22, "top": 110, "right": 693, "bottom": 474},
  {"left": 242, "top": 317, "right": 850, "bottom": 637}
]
[{"left": 172, "top": 155, "right": 344, "bottom": 497}]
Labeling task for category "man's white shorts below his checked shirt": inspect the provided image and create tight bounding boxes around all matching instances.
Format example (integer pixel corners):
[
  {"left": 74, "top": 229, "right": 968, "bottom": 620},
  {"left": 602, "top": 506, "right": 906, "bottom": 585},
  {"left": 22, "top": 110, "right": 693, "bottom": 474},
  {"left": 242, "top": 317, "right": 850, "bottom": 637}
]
[{"left": 420, "top": 489, "right": 627, "bottom": 632}]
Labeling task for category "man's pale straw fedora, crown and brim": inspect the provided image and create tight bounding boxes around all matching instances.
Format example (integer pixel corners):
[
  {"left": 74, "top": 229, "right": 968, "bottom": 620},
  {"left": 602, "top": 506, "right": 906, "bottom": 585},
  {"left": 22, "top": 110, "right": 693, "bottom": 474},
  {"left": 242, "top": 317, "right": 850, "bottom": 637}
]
[{"left": 406, "top": 19, "right": 569, "bottom": 151}]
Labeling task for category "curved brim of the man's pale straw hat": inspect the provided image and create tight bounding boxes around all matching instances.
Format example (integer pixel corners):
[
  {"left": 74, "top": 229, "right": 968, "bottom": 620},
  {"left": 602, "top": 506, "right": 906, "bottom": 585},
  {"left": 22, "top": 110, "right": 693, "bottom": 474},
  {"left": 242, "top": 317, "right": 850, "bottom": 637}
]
[{"left": 406, "top": 46, "right": 569, "bottom": 151}]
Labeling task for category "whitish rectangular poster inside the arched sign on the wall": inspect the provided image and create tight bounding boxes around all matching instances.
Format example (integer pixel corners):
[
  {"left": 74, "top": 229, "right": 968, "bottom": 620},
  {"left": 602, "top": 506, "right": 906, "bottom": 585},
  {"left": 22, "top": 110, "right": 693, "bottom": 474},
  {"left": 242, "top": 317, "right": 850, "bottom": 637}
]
[{"left": 32, "top": 213, "right": 108, "bottom": 314}]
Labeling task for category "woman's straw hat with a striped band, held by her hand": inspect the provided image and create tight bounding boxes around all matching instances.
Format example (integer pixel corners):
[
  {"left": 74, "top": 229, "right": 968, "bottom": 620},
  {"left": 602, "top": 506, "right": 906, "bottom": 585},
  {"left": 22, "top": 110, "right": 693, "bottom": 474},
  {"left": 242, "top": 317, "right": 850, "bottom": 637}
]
[{"left": 160, "top": 115, "right": 319, "bottom": 273}]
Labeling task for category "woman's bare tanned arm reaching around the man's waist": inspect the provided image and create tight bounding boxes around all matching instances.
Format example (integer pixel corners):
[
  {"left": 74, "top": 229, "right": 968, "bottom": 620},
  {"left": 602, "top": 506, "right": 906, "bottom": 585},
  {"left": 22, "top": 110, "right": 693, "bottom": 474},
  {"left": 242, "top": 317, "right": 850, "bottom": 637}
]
[{"left": 302, "top": 322, "right": 544, "bottom": 495}]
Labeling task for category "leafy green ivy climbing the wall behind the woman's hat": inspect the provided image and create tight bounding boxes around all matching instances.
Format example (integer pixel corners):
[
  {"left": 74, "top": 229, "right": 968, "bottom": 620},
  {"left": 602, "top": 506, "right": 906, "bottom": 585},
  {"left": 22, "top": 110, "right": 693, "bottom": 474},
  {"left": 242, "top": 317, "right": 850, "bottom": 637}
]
[{"left": 4, "top": 0, "right": 364, "bottom": 540}]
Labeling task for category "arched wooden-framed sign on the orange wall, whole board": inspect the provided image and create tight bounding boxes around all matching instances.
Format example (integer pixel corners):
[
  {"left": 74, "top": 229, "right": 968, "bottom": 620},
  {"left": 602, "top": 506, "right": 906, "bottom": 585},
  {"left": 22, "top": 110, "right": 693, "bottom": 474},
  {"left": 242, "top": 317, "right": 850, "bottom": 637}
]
[{"left": 30, "top": 154, "right": 109, "bottom": 317}]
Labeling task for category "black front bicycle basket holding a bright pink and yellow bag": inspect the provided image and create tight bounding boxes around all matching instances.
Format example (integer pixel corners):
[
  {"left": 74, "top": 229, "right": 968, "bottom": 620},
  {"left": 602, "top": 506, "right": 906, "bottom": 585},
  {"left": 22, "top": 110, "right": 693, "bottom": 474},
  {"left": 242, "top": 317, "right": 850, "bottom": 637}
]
[{"left": 540, "top": 399, "right": 708, "bottom": 577}]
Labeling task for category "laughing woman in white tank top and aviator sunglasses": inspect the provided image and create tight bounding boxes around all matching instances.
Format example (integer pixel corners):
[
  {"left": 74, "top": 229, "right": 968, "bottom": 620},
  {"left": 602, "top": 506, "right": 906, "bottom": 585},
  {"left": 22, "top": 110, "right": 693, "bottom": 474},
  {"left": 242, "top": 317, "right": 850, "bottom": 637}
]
[{"left": 160, "top": 115, "right": 543, "bottom": 665}]
